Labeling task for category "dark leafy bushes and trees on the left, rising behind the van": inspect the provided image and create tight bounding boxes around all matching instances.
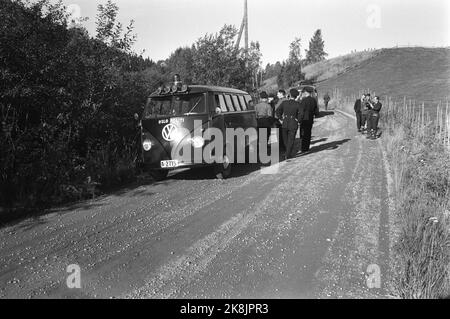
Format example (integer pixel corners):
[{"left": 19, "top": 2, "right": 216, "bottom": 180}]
[{"left": 0, "top": 0, "right": 259, "bottom": 212}]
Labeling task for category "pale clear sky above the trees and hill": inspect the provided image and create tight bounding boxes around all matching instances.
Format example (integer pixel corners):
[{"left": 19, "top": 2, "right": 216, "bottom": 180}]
[{"left": 63, "top": 0, "right": 450, "bottom": 65}]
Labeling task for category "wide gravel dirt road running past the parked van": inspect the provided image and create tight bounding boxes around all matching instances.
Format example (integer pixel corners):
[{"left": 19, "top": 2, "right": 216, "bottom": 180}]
[{"left": 0, "top": 113, "right": 390, "bottom": 298}]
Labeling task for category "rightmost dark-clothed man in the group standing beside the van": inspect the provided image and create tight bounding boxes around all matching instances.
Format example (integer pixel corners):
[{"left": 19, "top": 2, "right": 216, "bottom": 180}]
[{"left": 299, "top": 88, "right": 319, "bottom": 153}]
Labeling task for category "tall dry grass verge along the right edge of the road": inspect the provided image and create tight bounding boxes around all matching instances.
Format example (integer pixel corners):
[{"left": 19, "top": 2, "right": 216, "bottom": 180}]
[{"left": 383, "top": 123, "right": 450, "bottom": 299}]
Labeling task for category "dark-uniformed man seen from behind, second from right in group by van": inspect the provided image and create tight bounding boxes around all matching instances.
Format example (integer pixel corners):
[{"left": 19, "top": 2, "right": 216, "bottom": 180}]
[{"left": 276, "top": 89, "right": 300, "bottom": 159}]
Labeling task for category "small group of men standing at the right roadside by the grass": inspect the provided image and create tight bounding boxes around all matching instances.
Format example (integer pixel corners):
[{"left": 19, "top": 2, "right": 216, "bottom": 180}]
[{"left": 354, "top": 93, "right": 382, "bottom": 140}]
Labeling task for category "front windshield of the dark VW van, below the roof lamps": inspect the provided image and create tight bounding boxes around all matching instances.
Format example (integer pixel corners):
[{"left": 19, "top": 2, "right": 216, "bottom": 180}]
[{"left": 143, "top": 94, "right": 205, "bottom": 118}]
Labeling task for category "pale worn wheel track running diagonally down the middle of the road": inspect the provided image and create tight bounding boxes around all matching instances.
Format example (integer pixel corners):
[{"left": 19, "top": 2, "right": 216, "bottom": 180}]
[{"left": 126, "top": 113, "right": 356, "bottom": 298}]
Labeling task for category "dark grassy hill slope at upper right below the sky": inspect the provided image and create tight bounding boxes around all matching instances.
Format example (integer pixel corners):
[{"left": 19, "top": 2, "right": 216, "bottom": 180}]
[{"left": 318, "top": 48, "right": 450, "bottom": 104}]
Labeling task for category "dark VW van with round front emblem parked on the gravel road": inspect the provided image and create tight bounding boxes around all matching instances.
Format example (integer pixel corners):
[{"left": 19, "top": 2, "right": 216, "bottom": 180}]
[{"left": 141, "top": 83, "right": 257, "bottom": 180}]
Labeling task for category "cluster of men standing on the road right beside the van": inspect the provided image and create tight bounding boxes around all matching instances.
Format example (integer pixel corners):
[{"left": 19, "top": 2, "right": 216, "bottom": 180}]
[{"left": 255, "top": 87, "right": 319, "bottom": 159}]
